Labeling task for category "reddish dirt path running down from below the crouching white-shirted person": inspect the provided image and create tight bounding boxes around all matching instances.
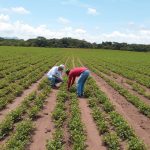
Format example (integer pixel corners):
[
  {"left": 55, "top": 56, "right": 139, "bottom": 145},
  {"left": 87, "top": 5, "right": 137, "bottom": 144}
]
[{"left": 29, "top": 90, "right": 58, "bottom": 150}]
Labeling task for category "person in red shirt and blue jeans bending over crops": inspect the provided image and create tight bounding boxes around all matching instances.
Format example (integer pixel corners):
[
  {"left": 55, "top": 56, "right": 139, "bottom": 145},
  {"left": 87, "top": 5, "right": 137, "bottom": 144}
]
[{"left": 66, "top": 67, "right": 90, "bottom": 97}]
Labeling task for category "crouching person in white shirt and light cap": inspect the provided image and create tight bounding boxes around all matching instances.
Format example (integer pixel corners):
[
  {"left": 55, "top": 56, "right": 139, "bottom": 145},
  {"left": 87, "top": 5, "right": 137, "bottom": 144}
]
[{"left": 47, "top": 64, "right": 65, "bottom": 88}]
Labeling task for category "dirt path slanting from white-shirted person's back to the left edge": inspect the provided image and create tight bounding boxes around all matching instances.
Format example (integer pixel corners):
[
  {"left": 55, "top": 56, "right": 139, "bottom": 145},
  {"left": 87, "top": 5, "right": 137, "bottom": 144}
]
[{"left": 0, "top": 75, "right": 45, "bottom": 122}]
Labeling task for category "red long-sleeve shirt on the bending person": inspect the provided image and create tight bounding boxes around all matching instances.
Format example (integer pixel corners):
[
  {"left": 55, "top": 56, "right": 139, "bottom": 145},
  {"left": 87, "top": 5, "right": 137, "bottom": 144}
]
[{"left": 68, "top": 67, "right": 87, "bottom": 88}]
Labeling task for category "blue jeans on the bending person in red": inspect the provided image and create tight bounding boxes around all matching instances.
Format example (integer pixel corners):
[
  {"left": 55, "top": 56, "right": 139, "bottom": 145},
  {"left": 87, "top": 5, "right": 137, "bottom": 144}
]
[{"left": 77, "top": 70, "right": 90, "bottom": 96}]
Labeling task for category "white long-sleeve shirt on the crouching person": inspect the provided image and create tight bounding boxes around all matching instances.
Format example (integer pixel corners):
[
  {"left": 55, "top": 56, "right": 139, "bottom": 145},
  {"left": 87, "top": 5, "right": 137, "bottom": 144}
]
[{"left": 47, "top": 66, "right": 62, "bottom": 79}]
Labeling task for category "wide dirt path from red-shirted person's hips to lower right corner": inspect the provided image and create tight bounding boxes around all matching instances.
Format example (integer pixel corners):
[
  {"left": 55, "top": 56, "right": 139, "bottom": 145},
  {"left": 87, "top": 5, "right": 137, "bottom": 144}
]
[{"left": 91, "top": 73, "right": 150, "bottom": 146}]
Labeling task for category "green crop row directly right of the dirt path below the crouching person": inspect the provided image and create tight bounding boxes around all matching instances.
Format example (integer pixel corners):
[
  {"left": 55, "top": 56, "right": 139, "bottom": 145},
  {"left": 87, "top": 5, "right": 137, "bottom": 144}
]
[{"left": 46, "top": 81, "right": 68, "bottom": 150}]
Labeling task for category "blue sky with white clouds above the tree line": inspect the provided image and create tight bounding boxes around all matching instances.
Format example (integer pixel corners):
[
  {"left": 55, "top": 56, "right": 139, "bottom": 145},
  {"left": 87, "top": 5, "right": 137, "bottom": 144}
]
[{"left": 0, "top": 0, "right": 150, "bottom": 44}]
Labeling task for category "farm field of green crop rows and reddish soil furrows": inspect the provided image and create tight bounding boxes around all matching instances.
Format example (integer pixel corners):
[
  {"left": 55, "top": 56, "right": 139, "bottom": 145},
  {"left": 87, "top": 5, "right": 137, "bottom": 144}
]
[{"left": 0, "top": 46, "right": 150, "bottom": 150}]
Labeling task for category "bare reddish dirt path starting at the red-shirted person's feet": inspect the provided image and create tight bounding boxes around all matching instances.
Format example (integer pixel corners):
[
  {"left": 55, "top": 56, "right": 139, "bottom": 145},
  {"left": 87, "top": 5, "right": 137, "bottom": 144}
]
[{"left": 79, "top": 98, "right": 106, "bottom": 150}]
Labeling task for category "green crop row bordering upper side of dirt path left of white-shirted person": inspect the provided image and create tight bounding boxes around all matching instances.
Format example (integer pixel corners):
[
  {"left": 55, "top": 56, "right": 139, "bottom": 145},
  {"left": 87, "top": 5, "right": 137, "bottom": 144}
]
[{"left": 0, "top": 56, "right": 61, "bottom": 109}]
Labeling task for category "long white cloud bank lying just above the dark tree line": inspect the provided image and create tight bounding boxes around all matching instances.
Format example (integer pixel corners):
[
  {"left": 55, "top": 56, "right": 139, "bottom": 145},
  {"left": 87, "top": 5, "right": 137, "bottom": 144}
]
[{"left": 0, "top": 14, "right": 150, "bottom": 44}]
